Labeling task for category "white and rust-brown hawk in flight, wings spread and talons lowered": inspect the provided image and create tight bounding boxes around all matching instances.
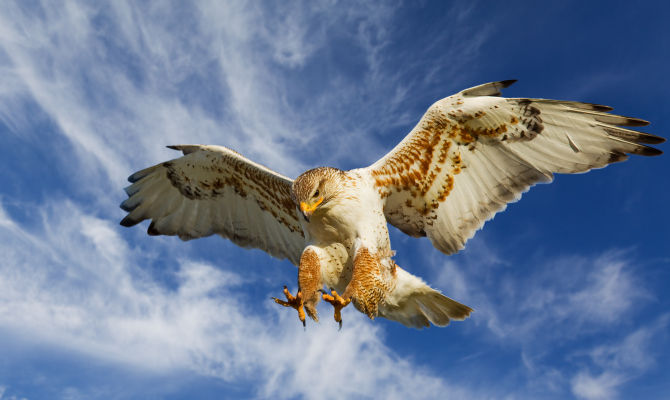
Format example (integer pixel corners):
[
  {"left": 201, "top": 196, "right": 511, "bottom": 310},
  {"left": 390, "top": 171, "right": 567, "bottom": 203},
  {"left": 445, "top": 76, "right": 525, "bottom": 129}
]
[{"left": 121, "top": 80, "right": 665, "bottom": 328}]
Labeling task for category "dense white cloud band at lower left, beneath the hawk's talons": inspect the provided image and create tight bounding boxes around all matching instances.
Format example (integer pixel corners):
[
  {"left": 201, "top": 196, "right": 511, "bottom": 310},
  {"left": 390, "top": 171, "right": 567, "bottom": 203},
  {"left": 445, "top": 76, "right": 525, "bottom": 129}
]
[{"left": 0, "top": 202, "right": 488, "bottom": 398}]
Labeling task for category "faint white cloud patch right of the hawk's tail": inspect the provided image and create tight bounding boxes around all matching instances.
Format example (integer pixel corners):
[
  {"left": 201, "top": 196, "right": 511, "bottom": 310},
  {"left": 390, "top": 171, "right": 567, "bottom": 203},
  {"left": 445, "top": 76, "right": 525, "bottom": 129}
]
[{"left": 437, "top": 238, "right": 650, "bottom": 343}]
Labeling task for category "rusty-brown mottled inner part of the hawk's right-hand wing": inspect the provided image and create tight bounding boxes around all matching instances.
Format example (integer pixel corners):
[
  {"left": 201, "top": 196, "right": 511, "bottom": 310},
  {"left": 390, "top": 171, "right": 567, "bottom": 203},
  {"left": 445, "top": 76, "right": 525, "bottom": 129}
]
[{"left": 370, "top": 98, "right": 512, "bottom": 236}]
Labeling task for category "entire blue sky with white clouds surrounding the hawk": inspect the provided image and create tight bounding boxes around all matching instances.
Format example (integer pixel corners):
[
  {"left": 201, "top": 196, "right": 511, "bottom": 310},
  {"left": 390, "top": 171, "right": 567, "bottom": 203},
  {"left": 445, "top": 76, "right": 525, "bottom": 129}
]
[{"left": 0, "top": 0, "right": 670, "bottom": 400}]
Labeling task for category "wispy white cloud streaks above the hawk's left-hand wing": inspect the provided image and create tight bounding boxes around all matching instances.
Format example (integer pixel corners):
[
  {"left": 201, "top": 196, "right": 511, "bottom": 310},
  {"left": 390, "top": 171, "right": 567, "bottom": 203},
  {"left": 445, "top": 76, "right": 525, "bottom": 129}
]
[{"left": 0, "top": 1, "right": 494, "bottom": 206}]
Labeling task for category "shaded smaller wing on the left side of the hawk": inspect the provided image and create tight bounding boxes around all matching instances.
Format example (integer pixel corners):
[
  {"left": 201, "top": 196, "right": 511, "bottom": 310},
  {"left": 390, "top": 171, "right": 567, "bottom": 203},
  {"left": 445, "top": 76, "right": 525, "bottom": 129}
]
[{"left": 121, "top": 145, "right": 305, "bottom": 265}]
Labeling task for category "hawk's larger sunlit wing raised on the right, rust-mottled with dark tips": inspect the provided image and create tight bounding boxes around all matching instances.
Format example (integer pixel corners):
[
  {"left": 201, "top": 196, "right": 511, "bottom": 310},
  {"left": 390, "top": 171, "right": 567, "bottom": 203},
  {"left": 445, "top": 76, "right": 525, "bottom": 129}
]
[{"left": 367, "top": 81, "right": 665, "bottom": 254}]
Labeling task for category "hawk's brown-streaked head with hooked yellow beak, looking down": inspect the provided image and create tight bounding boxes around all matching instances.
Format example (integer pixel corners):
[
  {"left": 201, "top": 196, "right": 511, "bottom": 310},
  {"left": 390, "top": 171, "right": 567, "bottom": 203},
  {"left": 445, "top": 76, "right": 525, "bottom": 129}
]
[{"left": 292, "top": 167, "right": 344, "bottom": 221}]
